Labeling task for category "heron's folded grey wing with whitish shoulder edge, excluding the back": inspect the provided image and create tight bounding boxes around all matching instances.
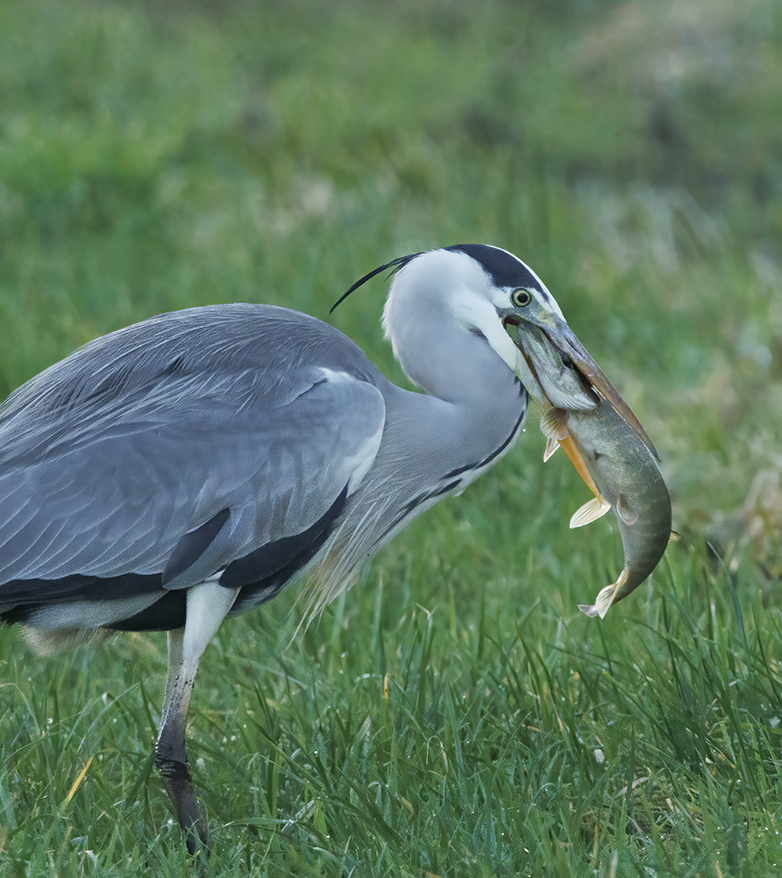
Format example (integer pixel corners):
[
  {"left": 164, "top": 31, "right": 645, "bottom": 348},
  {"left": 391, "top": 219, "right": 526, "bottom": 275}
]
[{"left": 0, "top": 367, "right": 385, "bottom": 608}]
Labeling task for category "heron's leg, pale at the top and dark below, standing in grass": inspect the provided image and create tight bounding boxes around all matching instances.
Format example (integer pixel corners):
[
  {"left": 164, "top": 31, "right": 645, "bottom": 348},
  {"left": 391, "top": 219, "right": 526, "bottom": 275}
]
[{"left": 155, "top": 581, "right": 239, "bottom": 854}]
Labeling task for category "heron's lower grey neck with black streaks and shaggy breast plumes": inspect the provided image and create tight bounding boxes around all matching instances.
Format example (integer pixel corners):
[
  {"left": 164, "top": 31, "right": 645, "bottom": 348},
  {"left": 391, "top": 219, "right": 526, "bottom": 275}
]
[{"left": 316, "top": 338, "right": 528, "bottom": 607}]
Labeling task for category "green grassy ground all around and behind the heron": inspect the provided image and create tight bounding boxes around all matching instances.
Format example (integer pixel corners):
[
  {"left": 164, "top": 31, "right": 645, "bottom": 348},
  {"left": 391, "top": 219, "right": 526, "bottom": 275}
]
[{"left": 0, "top": 0, "right": 782, "bottom": 878}]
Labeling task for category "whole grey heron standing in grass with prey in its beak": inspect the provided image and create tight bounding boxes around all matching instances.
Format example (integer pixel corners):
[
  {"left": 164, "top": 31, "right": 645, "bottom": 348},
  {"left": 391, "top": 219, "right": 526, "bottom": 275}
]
[{"left": 0, "top": 244, "right": 640, "bottom": 852}]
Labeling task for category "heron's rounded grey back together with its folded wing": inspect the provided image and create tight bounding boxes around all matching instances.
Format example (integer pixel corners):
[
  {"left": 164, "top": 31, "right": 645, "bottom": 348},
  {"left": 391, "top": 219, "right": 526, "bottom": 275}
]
[{"left": 0, "top": 305, "right": 385, "bottom": 607}]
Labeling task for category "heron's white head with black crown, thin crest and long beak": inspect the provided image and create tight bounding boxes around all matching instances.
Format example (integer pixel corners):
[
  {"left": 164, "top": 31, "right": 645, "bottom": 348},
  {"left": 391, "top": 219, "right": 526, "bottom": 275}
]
[{"left": 336, "top": 244, "right": 653, "bottom": 449}]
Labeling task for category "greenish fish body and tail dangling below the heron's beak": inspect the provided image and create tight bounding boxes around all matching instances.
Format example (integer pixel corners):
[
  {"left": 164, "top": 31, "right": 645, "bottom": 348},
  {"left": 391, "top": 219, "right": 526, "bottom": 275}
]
[{"left": 539, "top": 399, "right": 672, "bottom": 619}]
